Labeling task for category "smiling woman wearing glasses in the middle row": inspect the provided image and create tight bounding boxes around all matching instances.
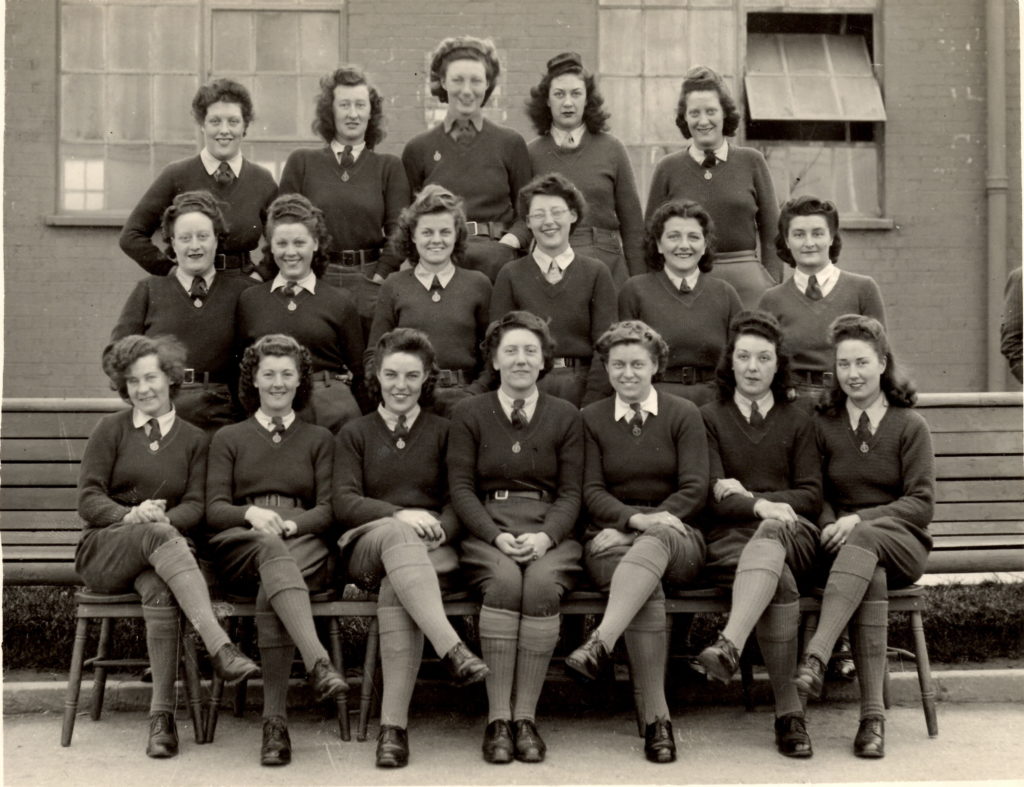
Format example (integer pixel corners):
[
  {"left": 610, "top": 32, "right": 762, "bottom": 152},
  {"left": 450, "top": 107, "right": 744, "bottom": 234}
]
[{"left": 490, "top": 172, "right": 618, "bottom": 407}]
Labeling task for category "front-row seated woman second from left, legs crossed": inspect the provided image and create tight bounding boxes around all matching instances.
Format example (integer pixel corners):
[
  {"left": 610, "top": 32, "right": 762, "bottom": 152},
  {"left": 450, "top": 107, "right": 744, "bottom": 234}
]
[{"left": 206, "top": 334, "right": 348, "bottom": 766}]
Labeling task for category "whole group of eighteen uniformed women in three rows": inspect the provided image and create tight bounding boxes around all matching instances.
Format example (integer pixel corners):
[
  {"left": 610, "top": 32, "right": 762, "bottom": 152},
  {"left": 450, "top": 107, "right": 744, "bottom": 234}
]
[{"left": 77, "top": 37, "right": 933, "bottom": 768}]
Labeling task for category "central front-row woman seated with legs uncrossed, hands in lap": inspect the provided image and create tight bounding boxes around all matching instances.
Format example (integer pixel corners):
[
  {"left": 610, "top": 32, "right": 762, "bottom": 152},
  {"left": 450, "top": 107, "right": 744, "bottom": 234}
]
[{"left": 447, "top": 311, "right": 583, "bottom": 763}]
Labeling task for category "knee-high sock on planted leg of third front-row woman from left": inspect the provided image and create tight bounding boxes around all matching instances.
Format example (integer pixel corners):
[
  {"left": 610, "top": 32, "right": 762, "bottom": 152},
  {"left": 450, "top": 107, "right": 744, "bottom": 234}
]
[{"left": 377, "top": 578, "right": 423, "bottom": 729}]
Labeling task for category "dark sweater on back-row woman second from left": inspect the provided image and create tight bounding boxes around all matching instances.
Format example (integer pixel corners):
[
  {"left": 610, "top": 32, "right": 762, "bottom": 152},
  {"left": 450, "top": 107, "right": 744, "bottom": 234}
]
[{"left": 278, "top": 146, "right": 412, "bottom": 275}]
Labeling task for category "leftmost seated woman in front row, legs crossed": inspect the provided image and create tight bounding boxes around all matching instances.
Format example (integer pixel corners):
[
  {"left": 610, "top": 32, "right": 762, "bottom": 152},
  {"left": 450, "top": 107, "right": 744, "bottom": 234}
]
[{"left": 75, "top": 335, "right": 259, "bottom": 757}]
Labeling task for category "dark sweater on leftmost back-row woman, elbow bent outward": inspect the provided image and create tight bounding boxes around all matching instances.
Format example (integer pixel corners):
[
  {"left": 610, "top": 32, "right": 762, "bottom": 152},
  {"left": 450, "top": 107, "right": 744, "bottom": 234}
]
[{"left": 119, "top": 156, "right": 278, "bottom": 276}]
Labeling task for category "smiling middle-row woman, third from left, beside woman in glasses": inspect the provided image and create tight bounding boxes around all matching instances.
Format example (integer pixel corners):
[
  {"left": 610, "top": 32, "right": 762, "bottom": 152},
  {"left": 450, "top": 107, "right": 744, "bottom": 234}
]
[{"left": 366, "top": 184, "right": 490, "bottom": 417}]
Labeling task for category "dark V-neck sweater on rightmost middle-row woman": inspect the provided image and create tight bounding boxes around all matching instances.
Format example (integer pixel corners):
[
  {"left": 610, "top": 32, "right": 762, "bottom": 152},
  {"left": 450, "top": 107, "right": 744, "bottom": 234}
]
[{"left": 758, "top": 270, "right": 886, "bottom": 371}]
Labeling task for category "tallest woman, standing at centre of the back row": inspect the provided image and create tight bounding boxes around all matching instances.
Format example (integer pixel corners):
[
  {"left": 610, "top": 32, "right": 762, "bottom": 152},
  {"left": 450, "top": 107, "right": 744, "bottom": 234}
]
[{"left": 401, "top": 36, "right": 530, "bottom": 281}]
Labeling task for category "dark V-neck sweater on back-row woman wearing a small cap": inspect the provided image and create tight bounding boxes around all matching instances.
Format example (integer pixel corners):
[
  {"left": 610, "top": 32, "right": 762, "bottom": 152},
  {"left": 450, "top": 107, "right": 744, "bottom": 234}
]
[{"left": 526, "top": 131, "right": 647, "bottom": 276}]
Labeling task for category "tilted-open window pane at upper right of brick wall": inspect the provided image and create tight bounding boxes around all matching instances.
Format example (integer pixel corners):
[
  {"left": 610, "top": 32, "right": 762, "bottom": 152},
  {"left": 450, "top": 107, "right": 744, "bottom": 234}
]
[{"left": 744, "top": 33, "right": 886, "bottom": 123}]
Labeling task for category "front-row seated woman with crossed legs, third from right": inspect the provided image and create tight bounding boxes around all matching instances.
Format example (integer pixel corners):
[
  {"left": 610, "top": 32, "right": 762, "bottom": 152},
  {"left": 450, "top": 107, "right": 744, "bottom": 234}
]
[{"left": 565, "top": 320, "right": 708, "bottom": 762}]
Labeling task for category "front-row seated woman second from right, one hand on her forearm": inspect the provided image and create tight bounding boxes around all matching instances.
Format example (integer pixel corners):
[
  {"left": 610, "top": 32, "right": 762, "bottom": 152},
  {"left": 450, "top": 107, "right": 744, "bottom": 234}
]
[{"left": 698, "top": 311, "right": 821, "bottom": 757}]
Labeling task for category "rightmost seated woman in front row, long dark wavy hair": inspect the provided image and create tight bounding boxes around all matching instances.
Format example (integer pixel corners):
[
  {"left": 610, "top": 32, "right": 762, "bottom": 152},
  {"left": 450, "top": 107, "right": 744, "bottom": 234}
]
[{"left": 794, "top": 314, "right": 935, "bottom": 758}]
